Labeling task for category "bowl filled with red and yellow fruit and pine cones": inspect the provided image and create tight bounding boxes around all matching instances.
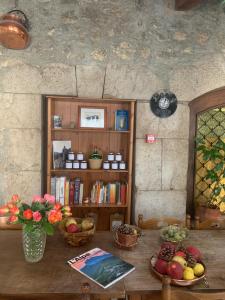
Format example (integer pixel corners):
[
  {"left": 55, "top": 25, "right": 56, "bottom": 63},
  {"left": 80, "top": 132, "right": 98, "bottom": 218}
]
[{"left": 150, "top": 242, "right": 206, "bottom": 286}]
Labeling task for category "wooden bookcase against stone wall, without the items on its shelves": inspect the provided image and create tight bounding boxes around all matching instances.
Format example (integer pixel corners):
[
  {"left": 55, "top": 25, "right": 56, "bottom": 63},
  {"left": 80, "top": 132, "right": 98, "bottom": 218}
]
[{"left": 43, "top": 96, "right": 135, "bottom": 230}]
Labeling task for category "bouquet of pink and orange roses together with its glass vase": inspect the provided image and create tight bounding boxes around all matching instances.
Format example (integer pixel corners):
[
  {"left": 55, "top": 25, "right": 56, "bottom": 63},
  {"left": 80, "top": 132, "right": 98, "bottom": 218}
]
[{"left": 0, "top": 194, "right": 71, "bottom": 262}]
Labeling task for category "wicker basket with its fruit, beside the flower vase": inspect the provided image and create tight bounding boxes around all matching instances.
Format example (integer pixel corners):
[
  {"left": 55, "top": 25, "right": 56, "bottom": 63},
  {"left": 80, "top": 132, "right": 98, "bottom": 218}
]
[{"left": 59, "top": 217, "right": 95, "bottom": 247}]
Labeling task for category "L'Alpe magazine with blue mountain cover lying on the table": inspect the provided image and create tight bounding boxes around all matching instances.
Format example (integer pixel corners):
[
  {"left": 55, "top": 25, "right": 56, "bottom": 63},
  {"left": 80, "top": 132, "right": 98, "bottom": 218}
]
[{"left": 67, "top": 248, "right": 135, "bottom": 289}]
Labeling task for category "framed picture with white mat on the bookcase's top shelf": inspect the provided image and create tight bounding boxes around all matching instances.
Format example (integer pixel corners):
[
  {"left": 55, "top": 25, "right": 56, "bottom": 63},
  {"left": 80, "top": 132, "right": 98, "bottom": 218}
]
[{"left": 79, "top": 106, "right": 106, "bottom": 129}]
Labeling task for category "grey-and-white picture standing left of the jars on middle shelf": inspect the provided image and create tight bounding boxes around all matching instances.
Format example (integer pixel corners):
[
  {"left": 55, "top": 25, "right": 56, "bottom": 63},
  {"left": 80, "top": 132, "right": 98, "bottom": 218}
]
[{"left": 52, "top": 141, "right": 71, "bottom": 169}]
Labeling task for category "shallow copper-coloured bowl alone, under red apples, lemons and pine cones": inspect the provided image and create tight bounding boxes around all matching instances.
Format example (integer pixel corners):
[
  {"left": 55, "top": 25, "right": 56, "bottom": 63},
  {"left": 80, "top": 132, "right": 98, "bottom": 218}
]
[{"left": 150, "top": 255, "right": 206, "bottom": 286}]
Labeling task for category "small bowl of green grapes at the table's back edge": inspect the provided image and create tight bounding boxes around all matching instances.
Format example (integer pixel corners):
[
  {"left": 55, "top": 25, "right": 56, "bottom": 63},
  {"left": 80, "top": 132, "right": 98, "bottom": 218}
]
[{"left": 160, "top": 224, "right": 188, "bottom": 243}]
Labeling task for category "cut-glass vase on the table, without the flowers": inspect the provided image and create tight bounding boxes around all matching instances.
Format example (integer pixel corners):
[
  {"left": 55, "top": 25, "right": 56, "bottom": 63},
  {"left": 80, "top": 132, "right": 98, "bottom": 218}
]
[{"left": 23, "top": 225, "right": 46, "bottom": 263}]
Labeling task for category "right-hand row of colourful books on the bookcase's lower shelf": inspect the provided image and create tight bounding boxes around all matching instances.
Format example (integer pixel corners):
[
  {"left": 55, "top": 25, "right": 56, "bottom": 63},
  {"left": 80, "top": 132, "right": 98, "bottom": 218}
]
[{"left": 91, "top": 181, "right": 128, "bottom": 205}]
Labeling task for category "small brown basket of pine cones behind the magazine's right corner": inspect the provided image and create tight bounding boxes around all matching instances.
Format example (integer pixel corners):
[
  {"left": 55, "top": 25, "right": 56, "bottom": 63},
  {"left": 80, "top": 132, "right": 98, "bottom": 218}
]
[{"left": 113, "top": 224, "right": 141, "bottom": 247}]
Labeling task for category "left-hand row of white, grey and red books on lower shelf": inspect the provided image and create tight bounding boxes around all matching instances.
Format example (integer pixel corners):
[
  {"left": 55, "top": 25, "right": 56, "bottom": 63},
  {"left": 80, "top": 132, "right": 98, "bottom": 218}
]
[{"left": 51, "top": 176, "right": 84, "bottom": 206}]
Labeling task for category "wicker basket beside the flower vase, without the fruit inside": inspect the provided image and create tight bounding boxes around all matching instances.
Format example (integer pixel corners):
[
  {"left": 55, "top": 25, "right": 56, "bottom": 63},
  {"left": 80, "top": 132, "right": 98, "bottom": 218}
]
[{"left": 59, "top": 218, "right": 95, "bottom": 247}]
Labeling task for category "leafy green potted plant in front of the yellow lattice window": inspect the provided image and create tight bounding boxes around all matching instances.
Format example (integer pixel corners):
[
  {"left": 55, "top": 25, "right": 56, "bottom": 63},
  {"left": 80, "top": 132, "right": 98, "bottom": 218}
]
[{"left": 196, "top": 139, "right": 225, "bottom": 219}]
